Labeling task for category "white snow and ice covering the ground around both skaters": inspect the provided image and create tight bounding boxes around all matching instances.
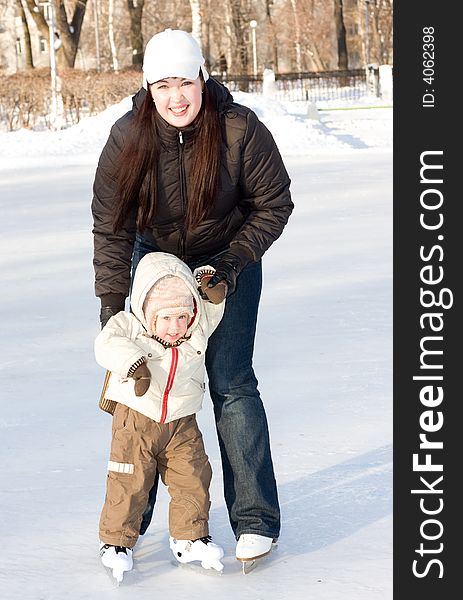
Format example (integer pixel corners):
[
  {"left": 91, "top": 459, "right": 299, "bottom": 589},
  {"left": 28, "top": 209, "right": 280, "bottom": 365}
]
[{"left": 0, "top": 93, "right": 392, "bottom": 600}]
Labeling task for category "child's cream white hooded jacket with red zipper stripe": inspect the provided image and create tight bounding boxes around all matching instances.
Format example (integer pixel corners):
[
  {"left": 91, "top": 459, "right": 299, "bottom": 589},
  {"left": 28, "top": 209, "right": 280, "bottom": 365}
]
[{"left": 95, "top": 252, "right": 225, "bottom": 423}]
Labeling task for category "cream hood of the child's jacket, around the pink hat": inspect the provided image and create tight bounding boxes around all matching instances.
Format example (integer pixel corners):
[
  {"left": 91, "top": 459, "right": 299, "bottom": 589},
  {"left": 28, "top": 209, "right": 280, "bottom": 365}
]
[{"left": 130, "top": 252, "right": 202, "bottom": 335}]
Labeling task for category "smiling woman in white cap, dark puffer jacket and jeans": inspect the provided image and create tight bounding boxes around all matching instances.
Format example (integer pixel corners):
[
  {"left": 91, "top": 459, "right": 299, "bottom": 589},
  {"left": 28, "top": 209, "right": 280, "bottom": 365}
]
[{"left": 92, "top": 29, "right": 293, "bottom": 560}]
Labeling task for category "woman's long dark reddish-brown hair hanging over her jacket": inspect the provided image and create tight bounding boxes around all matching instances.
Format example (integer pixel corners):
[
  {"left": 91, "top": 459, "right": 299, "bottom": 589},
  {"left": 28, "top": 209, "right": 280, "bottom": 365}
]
[{"left": 113, "top": 77, "right": 222, "bottom": 233}]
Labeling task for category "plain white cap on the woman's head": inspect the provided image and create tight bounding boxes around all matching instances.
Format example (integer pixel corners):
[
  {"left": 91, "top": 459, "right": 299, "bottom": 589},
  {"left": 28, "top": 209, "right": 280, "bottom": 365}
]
[{"left": 143, "top": 29, "right": 209, "bottom": 84}]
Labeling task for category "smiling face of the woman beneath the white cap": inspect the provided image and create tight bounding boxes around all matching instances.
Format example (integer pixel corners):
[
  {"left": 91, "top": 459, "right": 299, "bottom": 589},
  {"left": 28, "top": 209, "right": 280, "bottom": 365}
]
[{"left": 150, "top": 76, "right": 202, "bottom": 128}]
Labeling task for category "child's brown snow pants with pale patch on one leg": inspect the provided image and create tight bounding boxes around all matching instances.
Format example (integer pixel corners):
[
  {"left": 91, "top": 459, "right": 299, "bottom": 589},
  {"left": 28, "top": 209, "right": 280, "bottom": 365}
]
[{"left": 100, "top": 403, "right": 212, "bottom": 548}]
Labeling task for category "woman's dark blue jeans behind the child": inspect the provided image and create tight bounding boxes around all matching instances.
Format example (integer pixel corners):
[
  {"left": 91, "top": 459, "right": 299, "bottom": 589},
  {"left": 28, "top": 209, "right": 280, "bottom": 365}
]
[{"left": 132, "top": 238, "right": 280, "bottom": 539}]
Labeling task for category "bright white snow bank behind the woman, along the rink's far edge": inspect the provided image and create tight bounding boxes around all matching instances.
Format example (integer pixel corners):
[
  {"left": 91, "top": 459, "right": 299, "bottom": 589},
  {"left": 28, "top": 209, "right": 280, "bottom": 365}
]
[{"left": 0, "top": 92, "right": 392, "bottom": 168}]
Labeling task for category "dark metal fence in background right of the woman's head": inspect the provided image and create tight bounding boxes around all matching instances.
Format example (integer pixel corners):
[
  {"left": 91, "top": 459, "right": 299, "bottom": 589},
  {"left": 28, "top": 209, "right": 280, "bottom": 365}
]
[{"left": 214, "top": 68, "right": 379, "bottom": 102}]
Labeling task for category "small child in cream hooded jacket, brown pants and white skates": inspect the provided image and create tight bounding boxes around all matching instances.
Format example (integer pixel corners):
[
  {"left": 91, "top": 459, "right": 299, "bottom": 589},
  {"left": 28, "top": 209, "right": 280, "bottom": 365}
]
[{"left": 95, "top": 252, "right": 226, "bottom": 581}]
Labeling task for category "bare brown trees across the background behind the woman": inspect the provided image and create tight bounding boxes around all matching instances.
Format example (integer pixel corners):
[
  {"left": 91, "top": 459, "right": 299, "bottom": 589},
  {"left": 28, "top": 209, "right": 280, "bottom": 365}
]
[{"left": 0, "top": 0, "right": 393, "bottom": 74}]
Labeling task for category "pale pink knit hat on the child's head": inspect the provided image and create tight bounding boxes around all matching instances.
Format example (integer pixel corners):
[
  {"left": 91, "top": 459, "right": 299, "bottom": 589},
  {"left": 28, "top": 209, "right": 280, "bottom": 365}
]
[{"left": 143, "top": 275, "right": 194, "bottom": 333}]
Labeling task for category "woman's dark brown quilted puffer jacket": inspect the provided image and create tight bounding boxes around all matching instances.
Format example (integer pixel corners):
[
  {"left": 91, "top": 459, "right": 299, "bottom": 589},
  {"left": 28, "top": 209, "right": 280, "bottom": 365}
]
[{"left": 92, "top": 78, "right": 293, "bottom": 308}]
